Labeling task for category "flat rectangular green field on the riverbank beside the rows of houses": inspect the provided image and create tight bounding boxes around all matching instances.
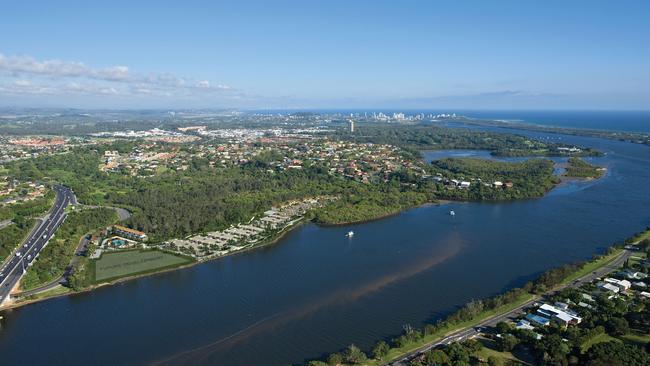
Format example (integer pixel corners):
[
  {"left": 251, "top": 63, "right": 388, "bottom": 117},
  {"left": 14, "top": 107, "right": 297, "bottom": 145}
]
[{"left": 92, "top": 250, "right": 191, "bottom": 282}]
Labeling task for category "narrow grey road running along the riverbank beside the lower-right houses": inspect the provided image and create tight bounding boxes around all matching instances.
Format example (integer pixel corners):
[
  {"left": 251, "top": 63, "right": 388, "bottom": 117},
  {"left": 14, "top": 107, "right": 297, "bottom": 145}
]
[{"left": 388, "top": 250, "right": 634, "bottom": 366}]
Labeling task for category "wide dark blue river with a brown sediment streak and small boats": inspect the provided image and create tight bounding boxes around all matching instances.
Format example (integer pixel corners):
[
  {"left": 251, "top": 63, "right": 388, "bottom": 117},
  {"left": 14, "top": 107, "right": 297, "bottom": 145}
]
[{"left": 0, "top": 126, "right": 650, "bottom": 365}]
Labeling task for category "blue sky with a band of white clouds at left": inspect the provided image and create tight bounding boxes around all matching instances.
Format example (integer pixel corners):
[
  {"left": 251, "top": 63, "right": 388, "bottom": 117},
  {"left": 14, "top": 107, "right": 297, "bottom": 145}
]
[{"left": 0, "top": 0, "right": 650, "bottom": 110}]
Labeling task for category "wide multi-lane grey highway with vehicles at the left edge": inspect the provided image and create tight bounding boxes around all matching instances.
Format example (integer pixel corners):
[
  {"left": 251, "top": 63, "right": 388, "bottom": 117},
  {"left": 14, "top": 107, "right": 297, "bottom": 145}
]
[{"left": 0, "top": 185, "right": 77, "bottom": 305}]
